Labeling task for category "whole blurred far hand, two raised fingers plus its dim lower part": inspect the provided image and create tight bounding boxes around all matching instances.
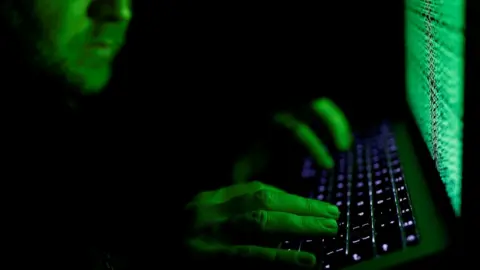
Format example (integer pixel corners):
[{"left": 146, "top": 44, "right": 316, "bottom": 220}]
[{"left": 233, "top": 98, "right": 353, "bottom": 183}]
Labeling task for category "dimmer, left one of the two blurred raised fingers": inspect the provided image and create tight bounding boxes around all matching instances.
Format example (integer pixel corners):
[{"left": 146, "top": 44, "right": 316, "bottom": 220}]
[{"left": 275, "top": 113, "right": 334, "bottom": 168}]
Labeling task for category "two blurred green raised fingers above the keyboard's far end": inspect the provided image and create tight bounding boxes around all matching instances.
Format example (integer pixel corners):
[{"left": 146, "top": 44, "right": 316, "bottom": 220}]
[{"left": 275, "top": 98, "right": 353, "bottom": 168}]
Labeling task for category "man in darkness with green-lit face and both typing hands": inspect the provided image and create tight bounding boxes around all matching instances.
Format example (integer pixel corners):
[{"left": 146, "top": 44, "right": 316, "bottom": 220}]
[{"left": 1, "top": 0, "right": 352, "bottom": 269}]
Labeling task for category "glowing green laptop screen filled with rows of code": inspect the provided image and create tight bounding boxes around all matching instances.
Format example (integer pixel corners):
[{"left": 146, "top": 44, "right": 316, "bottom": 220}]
[{"left": 405, "top": 0, "right": 465, "bottom": 216}]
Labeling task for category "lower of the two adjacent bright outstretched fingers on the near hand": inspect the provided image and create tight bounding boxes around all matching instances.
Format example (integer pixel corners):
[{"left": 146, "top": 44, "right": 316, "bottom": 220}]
[{"left": 228, "top": 210, "right": 338, "bottom": 238}]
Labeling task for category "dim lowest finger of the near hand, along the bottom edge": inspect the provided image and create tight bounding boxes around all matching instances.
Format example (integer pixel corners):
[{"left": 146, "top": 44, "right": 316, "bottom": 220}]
[{"left": 230, "top": 246, "right": 316, "bottom": 268}]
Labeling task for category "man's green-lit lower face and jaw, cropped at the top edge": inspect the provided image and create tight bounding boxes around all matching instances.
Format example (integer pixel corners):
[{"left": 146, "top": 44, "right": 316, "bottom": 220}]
[{"left": 2, "top": 0, "right": 132, "bottom": 95}]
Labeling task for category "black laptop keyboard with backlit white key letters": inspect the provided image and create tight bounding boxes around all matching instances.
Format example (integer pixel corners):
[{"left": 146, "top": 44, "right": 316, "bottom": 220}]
[{"left": 280, "top": 125, "right": 419, "bottom": 269}]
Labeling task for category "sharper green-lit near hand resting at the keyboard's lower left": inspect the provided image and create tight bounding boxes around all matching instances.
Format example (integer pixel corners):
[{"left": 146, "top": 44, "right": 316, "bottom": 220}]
[{"left": 187, "top": 182, "right": 339, "bottom": 267}]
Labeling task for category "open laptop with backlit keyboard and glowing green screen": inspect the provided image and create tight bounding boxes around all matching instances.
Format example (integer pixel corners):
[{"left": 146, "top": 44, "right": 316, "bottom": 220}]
[{"left": 279, "top": 0, "right": 470, "bottom": 270}]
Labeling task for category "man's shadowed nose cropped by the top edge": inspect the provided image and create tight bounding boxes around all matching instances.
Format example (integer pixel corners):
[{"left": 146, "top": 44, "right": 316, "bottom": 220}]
[{"left": 91, "top": 0, "right": 132, "bottom": 22}]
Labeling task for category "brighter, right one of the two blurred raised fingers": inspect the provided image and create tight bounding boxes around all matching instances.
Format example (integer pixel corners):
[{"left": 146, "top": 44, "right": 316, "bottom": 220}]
[{"left": 312, "top": 98, "right": 353, "bottom": 151}]
